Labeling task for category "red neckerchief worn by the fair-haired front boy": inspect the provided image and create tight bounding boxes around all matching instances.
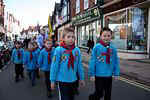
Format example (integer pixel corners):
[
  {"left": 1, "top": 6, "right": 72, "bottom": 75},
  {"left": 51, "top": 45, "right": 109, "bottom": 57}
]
[{"left": 60, "top": 42, "right": 75, "bottom": 69}]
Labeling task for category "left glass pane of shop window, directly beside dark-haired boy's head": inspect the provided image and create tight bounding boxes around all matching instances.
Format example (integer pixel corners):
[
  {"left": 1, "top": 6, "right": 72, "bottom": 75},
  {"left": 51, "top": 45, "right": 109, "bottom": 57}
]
[{"left": 107, "top": 10, "right": 127, "bottom": 50}]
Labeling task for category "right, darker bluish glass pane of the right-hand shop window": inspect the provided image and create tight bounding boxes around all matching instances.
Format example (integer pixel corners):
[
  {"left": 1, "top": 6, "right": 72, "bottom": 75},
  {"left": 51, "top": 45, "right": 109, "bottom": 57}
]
[{"left": 127, "top": 8, "right": 148, "bottom": 51}]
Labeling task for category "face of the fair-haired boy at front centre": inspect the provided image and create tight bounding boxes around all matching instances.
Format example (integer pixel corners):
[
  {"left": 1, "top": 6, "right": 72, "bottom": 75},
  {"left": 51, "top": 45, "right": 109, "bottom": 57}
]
[{"left": 64, "top": 32, "right": 75, "bottom": 45}]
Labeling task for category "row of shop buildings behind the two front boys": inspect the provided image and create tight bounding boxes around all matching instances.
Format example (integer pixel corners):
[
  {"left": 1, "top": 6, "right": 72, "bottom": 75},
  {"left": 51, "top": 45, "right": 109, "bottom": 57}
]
[{"left": 51, "top": 0, "right": 150, "bottom": 59}]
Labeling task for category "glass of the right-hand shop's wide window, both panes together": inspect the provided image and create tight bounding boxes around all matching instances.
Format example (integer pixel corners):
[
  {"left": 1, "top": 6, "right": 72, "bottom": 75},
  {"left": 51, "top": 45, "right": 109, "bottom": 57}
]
[{"left": 105, "top": 8, "right": 148, "bottom": 51}]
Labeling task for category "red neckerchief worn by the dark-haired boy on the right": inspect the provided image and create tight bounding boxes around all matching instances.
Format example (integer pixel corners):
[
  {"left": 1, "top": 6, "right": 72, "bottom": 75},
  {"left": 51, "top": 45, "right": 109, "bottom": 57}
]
[{"left": 100, "top": 40, "right": 111, "bottom": 64}]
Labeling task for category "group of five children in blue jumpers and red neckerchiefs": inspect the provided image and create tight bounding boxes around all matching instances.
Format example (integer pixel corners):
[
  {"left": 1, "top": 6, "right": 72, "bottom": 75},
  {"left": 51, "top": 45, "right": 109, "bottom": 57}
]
[{"left": 11, "top": 28, "right": 120, "bottom": 100}]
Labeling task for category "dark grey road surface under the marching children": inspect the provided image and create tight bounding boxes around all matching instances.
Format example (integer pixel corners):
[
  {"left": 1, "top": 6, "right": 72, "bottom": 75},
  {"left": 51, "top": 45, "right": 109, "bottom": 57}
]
[{"left": 0, "top": 65, "right": 150, "bottom": 100}]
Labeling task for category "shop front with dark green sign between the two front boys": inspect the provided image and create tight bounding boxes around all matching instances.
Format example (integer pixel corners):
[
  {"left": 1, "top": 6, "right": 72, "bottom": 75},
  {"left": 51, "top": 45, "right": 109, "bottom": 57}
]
[{"left": 72, "top": 6, "right": 101, "bottom": 48}]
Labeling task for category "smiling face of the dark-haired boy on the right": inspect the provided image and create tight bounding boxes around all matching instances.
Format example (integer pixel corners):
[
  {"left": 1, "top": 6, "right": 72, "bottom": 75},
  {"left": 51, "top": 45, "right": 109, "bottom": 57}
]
[{"left": 101, "top": 31, "right": 112, "bottom": 43}]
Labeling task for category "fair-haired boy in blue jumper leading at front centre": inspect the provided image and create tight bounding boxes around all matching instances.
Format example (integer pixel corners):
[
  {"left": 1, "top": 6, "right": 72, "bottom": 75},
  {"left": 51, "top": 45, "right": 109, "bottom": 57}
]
[{"left": 50, "top": 28, "right": 85, "bottom": 100}]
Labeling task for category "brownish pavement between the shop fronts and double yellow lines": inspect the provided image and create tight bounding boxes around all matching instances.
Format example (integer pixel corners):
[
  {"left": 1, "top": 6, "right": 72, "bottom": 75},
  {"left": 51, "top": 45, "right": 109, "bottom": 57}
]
[{"left": 81, "top": 49, "right": 150, "bottom": 86}]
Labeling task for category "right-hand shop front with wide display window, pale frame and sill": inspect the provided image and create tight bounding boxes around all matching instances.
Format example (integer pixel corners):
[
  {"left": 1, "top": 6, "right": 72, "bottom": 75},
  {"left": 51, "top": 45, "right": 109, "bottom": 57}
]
[{"left": 104, "top": 5, "right": 150, "bottom": 59}]
